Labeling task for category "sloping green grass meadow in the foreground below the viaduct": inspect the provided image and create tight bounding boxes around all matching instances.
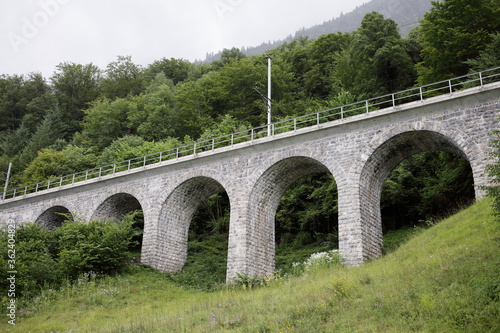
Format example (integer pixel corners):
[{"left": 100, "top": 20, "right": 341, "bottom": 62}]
[{"left": 0, "top": 200, "right": 500, "bottom": 333}]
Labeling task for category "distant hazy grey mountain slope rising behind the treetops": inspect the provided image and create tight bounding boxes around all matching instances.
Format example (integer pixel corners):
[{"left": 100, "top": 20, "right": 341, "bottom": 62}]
[{"left": 205, "top": 0, "right": 432, "bottom": 62}]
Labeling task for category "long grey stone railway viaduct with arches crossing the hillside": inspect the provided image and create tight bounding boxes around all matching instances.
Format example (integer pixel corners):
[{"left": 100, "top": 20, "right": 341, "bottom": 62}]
[{"left": 0, "top": 82, "right": 500, "bottom": 280}]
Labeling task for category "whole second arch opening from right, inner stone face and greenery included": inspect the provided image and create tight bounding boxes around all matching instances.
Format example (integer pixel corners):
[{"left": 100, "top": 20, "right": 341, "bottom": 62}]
[{"left": 247, "top": 157, "right": 338, "bottom": 276}]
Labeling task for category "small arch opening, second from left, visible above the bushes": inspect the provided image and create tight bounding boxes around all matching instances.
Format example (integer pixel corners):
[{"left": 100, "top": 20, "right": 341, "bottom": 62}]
[{"left": 91, "top": 193, "right": 142, "bottom": 220}]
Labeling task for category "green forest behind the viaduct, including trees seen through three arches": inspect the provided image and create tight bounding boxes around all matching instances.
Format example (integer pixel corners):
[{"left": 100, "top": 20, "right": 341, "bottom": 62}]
[{"left": 0, "top": 0, "right": 500, "bottom": 252}]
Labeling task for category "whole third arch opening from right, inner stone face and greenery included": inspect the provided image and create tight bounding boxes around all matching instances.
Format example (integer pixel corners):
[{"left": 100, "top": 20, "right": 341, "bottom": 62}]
[{"left": 153, "top": 176, "right": 230, "bottom": 288}]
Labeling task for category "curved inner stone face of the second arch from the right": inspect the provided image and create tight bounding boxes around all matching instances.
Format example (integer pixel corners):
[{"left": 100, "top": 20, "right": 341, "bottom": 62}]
[{"left": 240, "top": 156, "right": 331, "bottom": 280}]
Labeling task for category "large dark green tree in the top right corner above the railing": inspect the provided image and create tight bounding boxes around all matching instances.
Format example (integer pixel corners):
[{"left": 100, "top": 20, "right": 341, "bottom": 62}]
[{"left": 418, "top": 0, "right": 500, "bottom": 84}]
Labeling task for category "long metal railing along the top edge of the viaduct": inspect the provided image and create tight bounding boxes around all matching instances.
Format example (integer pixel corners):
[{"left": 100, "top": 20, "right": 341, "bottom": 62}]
[{"left": 5, "top": 67, "right": 500, "bottom": 200}]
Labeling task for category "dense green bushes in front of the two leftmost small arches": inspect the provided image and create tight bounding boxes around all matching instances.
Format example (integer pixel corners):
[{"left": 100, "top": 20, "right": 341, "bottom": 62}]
[{"left": 0, "top": 216, "right": 140, "bottom": 297}]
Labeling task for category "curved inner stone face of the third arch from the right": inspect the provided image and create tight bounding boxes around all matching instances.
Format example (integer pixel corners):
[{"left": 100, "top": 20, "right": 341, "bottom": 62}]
[{"left": 154, "top": 176, "right": 226, "bottom": 273}]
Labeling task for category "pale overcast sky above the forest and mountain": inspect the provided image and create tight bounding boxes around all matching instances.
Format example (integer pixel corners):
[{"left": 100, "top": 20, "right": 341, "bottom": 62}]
[{"left": 0, "top": 0, "right": 369, "bottom": 77}]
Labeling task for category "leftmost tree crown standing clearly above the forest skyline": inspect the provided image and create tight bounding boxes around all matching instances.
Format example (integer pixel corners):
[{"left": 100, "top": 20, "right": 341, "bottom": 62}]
[{"left": 50, "top": 62, "right": 101, "bottom": 131}]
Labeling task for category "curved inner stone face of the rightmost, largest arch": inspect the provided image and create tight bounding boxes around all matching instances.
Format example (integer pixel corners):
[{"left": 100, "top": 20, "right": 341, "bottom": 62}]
[{"left": 359, "top": 130, "right": 470, "bottom": 259}]
